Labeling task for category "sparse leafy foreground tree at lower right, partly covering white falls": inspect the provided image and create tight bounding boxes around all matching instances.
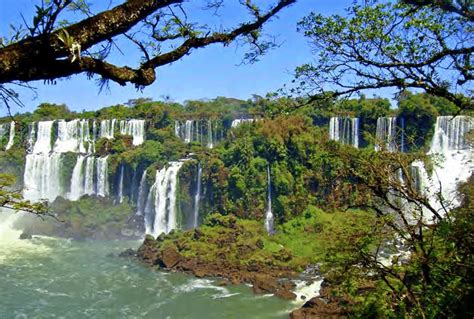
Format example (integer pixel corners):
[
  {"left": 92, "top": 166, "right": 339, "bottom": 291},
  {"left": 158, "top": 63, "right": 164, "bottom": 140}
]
[{"left": 327, "top": 150, "right": 474, "bottom": 318}]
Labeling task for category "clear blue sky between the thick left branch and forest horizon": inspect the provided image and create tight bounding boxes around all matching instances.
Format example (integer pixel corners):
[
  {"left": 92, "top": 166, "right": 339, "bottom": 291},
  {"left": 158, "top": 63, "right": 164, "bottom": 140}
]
[{"left": 0, "top": 0, "right": 352, "bottom": 116}]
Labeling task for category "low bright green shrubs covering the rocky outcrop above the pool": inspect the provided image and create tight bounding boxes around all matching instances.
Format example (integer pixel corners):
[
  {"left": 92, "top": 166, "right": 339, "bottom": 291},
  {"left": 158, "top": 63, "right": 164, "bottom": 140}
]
[{"left": 150, "top": 207, "right": 375, "bottom": 271}]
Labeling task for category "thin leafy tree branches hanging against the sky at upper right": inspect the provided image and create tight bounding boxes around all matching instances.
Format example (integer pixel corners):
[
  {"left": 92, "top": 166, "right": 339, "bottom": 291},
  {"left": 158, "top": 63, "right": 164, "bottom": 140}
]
[{"left": 296, "top": 0, "right": 474, "bottom": 109}]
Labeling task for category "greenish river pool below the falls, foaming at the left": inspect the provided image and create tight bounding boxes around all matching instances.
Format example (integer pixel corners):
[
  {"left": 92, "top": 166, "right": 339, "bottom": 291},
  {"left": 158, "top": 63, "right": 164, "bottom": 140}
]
[{"left": 0, "top": 232, "right": 295, "bottom": 319}]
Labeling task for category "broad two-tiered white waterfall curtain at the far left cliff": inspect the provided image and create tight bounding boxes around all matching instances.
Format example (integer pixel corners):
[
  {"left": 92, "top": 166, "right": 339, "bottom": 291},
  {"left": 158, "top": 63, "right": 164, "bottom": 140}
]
[{"left": 23, "top": 120, "right": 115, "bottom": 201}]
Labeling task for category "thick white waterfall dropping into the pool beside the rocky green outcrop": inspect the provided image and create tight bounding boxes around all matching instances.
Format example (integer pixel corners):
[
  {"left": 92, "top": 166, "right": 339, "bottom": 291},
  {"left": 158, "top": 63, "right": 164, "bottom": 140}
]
[{"left": 145, "top": 162, "right": 183, "bottom": 237}]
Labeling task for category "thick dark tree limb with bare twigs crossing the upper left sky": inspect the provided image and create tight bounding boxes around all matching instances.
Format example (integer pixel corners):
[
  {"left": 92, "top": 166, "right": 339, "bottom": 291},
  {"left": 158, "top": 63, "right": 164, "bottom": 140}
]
[{"left": 0, "top": 0, "right": 296, "bottom": 106}]
